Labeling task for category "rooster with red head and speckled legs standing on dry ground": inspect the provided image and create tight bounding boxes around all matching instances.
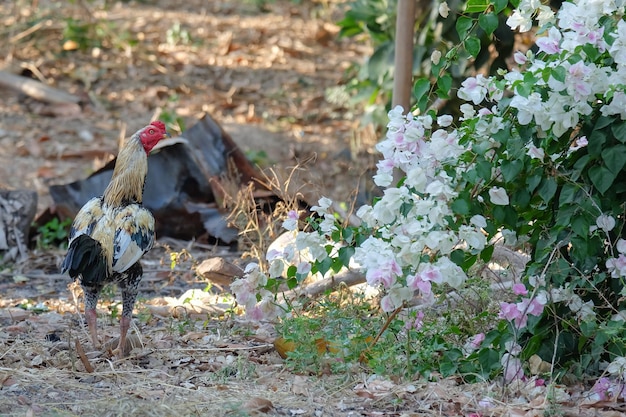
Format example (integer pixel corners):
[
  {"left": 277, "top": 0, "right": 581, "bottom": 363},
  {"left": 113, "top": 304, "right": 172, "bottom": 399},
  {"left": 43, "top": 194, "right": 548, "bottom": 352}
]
[{"left": 62, "top": 121, "right": 167, "bottom": 356}]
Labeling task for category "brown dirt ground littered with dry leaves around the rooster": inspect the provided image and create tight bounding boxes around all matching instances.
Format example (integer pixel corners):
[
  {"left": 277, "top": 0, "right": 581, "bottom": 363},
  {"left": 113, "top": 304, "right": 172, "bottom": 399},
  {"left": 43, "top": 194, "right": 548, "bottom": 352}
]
[{"left": 0, "top": 0, "right": 608, "bottom": 417}]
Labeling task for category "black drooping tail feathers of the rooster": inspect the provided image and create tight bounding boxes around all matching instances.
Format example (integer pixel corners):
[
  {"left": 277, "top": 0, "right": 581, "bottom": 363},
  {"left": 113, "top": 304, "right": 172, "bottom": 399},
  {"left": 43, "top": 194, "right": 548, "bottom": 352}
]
[{"left": 61, "top": 235, "right": 108, "bottom": 286}]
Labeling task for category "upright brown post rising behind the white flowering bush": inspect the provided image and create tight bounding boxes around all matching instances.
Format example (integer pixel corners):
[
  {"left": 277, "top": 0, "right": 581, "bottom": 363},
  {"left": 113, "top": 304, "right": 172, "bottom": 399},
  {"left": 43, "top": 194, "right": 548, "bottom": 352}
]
[{"left": 391, "top": 0, "right": 416, "bottom": 113}]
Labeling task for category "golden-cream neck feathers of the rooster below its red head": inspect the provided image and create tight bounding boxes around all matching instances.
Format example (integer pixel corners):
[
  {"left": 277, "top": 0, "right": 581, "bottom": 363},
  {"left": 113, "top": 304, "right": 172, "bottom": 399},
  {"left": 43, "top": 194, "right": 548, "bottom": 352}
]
[{"left": 103, "top": 134, "right": 148, "bottom": 206}]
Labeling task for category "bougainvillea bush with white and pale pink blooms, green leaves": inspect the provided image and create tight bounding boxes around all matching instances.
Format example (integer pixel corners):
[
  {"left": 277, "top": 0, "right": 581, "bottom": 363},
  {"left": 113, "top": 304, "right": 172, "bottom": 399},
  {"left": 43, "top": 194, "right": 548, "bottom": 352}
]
[{"left": 233, "top": 0, "right": 626, "bottom": 397}]
